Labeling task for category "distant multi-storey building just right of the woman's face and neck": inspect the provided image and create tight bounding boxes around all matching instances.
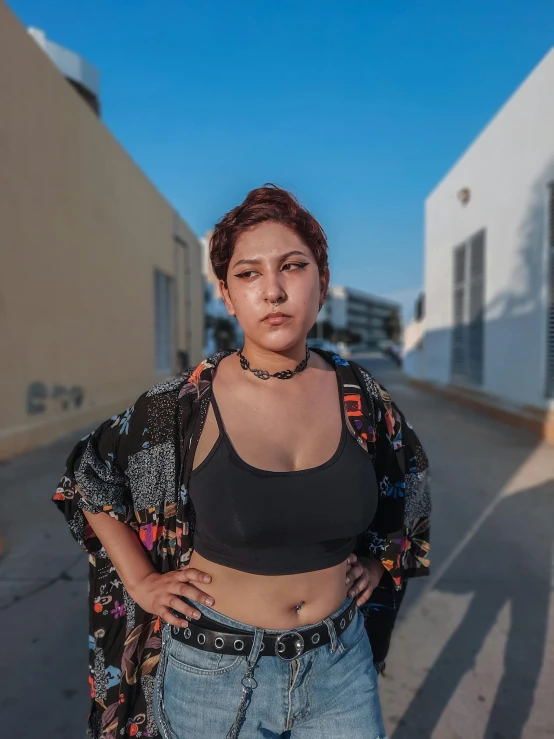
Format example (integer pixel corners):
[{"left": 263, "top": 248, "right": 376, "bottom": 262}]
[{"left": 317, "top": 285, "right": 400, "bottom": 349}]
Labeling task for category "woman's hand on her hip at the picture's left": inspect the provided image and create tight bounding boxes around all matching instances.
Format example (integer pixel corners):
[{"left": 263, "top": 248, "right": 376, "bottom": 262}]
[{"left": 129, "top": 567, "right": 214, "bottom": 628}]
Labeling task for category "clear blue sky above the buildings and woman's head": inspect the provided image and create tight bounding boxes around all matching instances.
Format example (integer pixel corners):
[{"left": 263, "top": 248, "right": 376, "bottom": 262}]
[{"left": 8, "top": 0, "right": 554, "bottom": 318}]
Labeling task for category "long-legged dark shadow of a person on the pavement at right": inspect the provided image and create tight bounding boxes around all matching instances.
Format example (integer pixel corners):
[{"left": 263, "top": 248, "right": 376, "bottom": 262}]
[{"left": 392, "top": 480, "right": 554, "bottom": 739}]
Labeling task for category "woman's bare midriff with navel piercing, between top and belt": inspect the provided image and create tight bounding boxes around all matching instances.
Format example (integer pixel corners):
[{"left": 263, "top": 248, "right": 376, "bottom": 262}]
[{"left": 190, "top": 552, "right": 348, "bottom": 629}]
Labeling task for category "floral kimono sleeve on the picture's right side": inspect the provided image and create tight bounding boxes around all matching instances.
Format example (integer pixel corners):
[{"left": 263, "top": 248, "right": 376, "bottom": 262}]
[{"left": 356, "top": 370, "right": 431, "bottom": 589}]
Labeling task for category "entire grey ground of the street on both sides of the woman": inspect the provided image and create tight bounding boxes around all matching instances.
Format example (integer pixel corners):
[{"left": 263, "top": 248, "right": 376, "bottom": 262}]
[{"left": 0, "top": 357, "right": 554, "bottom": 739}]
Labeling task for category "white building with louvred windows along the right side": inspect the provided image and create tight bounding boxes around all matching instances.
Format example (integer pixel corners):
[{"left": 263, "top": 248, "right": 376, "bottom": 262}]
[{"left": 406, "top": 49, "right": 554, "bottom": 434}]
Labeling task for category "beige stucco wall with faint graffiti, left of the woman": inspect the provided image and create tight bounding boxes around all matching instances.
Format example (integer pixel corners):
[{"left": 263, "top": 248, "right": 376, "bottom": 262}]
[{"left": 0, "top": 1, "right": 203, "bottom": 459}]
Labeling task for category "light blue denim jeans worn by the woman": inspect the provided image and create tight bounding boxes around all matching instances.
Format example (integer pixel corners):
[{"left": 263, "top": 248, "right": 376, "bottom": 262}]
[{"left": 154, "top": 598, "right": 385, "bottom": 739}]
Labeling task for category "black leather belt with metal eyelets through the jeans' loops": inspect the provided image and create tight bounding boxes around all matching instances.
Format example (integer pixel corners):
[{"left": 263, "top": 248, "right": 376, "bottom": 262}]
[{"left": 171, "top": 600, "right": 356, "bottom": 662}]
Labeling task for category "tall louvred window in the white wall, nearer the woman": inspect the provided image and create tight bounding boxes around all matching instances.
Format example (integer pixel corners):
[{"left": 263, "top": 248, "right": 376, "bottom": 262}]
[{"left": 451, "top": 231, "right": 485, "bottom": 385}]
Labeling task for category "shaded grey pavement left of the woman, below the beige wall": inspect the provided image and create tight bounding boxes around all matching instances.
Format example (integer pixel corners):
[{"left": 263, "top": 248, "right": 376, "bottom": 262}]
[{"left": 0, "top": 429, "right": 90, "bottom": 739}]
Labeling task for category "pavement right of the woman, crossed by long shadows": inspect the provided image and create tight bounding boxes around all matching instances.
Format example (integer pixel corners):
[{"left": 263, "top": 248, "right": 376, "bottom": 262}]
[{"left": 358, "top": 360, "right": 554, "bottom": 739}]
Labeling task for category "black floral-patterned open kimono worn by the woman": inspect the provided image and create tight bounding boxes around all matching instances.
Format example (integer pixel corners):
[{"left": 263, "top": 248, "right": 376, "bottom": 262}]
[{"left": 53, "top": 352, "right": 430, "bottom": 739}]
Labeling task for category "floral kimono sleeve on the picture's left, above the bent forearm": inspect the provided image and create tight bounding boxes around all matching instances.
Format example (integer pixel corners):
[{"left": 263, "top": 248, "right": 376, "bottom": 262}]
[{"left": 52, "top": 406, "right": 140, "bottom": 554}]
